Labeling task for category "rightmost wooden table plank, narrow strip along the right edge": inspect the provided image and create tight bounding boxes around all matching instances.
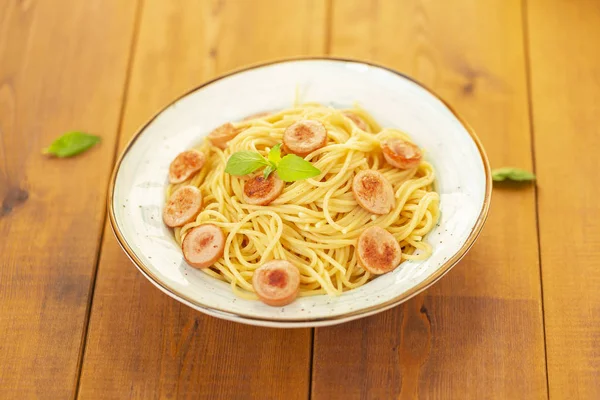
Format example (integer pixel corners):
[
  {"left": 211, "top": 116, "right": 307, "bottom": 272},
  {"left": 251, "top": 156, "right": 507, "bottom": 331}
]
[{"left": 527, "top": 0, "right": 600, "bottom": 399}]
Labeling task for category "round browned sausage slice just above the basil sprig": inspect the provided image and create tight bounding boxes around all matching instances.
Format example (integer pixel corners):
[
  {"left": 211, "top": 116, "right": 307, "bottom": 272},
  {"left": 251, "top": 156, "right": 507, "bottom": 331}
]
[{"left": 283, "top": 119, "right": 327, "bottom": 157}]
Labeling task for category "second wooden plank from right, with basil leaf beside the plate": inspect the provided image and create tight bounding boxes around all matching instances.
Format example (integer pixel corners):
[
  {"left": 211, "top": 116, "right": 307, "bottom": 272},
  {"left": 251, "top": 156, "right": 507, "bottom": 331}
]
[{"left": 312, "top": 0, "right": 547, "bottom": 399}]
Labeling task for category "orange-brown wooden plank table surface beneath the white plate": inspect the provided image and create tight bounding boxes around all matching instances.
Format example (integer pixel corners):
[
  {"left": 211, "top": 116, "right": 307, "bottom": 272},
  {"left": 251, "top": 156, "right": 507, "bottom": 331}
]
[{"left": 0, "top": 0, "right": 600, "bottom": 399}]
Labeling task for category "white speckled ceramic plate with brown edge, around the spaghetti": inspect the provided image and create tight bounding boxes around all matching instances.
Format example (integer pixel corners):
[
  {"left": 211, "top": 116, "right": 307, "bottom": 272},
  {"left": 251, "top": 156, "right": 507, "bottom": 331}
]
[{"left": 108, "top": 59, "right": 491, "bottom": 327}]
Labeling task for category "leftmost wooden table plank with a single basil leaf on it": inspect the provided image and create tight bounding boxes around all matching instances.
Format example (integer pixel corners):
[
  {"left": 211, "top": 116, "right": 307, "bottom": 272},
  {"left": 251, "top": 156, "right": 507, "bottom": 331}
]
[{"left": 0, "top": 0, "right": 136, "bottom": 399}]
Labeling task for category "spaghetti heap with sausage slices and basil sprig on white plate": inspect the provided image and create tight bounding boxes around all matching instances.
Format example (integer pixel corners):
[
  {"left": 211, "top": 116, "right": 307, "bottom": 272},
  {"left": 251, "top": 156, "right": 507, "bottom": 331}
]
[{"left": 163, "top": 103, "right": 439, "bottom": 306}]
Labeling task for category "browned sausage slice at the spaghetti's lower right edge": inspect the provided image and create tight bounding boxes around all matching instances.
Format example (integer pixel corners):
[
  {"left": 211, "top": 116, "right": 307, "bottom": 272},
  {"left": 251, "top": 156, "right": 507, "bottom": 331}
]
[{"left": 356, "top": 226, "right": 402, "bottom": 275}]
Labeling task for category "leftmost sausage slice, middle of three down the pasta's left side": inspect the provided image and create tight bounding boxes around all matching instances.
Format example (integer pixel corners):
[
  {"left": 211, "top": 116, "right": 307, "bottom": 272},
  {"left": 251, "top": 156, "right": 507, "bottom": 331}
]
[{"left": 163, "top": 185, "right": 202, "bottom": 228}]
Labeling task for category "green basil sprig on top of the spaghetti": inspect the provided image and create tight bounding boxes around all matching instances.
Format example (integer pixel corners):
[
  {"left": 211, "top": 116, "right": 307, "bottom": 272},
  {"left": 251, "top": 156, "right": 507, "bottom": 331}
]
[{"left": 225, "top": 143, "right": 321, "bottom": 182}]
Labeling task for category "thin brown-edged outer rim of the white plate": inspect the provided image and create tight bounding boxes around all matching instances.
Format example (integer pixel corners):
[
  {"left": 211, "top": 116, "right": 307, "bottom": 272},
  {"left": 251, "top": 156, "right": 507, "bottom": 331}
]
[{"left": 107, "top": 56, "right": 492, "bottom": 327}]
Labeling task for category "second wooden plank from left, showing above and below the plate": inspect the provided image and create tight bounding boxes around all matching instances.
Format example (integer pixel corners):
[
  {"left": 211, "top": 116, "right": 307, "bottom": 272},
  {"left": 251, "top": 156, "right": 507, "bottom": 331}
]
[{"left": 80, "top": 0, "right": 325, "bottom": 399}]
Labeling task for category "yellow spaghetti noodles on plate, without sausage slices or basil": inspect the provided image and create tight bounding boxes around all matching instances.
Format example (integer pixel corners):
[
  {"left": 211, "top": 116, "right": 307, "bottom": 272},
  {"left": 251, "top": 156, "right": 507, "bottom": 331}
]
[{"left": 167, "top": 103, "right": 439, "bottom": 299}]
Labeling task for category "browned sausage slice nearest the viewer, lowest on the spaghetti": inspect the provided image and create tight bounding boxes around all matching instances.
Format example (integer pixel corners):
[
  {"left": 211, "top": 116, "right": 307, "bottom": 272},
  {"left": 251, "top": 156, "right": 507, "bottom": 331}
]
[{"left": 252, "top": 260, "right": 300, "bottom": 307}]
